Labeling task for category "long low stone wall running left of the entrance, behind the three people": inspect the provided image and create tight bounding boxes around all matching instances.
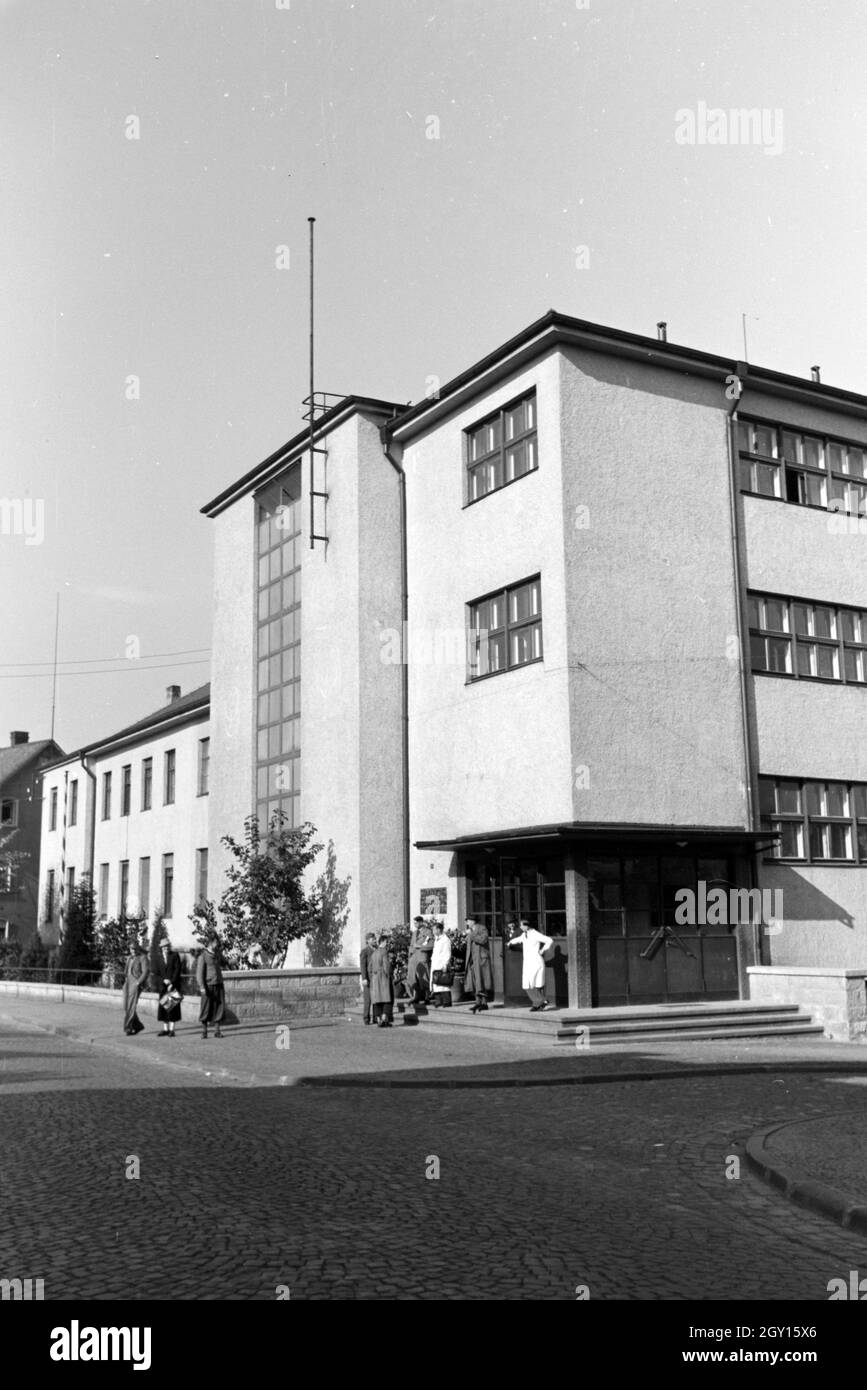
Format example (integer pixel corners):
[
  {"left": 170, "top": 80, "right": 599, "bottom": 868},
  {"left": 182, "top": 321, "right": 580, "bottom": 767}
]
[{"left": 0, "top": 966, "right": 361, "bottom": 1022}]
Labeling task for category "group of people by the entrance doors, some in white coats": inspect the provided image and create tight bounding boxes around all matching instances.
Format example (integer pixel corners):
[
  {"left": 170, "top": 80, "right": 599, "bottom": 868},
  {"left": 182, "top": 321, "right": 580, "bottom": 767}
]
[{"left": 360, "top": 917, "right": 553, "bottom": 1029}]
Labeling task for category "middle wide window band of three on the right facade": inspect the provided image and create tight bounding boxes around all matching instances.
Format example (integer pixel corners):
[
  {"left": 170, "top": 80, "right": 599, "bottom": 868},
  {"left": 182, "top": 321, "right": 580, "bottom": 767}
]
[{"left": 748, "top": 594, "right": 867, "bottom": 685}]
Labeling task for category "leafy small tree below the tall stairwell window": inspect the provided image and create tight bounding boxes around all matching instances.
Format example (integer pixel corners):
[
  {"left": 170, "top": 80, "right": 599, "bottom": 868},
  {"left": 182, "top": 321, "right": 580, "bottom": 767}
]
[{"left": 220, "top": 810, "right": 322, "bottom": 969}]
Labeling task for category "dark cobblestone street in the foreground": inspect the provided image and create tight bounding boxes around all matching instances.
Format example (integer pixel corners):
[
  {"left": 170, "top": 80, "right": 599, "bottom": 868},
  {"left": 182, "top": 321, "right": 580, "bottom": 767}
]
[{"left": 0, "top": 1024, "right": 867, "bottom": 1301}]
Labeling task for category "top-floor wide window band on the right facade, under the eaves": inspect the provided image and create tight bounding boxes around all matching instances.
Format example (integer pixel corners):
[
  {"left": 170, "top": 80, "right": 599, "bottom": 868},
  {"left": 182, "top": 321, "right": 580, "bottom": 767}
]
[{"left": 738, "top": 420, "right": 867, "bottom": 514}]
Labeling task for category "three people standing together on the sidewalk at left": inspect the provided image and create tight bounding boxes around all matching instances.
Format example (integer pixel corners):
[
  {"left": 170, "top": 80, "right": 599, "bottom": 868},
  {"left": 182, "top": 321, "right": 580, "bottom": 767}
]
[{"left": 124, "top": 931, "right": 225, "bottom": 1038}]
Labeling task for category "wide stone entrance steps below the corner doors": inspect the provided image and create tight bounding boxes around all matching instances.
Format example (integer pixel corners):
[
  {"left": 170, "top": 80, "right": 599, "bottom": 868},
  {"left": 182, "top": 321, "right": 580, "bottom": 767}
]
[{"left": 395, "top": 999, "right": 824, "bottom": 1047}]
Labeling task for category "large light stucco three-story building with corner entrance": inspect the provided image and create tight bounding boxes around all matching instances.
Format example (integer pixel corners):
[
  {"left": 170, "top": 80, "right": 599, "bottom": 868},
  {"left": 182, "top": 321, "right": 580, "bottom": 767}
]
[{"left": 204, "top": 313, "right": 867, "bottom": 1005}]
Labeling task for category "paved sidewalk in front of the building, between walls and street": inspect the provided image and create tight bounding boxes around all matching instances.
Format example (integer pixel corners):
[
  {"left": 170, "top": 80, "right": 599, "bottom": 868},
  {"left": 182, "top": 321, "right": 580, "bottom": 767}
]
[{"left": 0, "top": 998, "right": 867, "bottom": 1088}]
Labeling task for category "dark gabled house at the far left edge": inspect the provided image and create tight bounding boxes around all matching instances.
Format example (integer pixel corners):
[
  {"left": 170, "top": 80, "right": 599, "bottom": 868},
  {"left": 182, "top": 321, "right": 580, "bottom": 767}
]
[{"left": 0, "top": 730, "right": 63, "bottom": 942}]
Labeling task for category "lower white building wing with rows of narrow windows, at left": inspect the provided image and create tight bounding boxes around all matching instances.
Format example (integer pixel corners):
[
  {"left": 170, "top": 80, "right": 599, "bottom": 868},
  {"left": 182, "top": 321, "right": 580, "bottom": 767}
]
[{"left": 39, "top": 685, "right": 210, "bottom": 947}]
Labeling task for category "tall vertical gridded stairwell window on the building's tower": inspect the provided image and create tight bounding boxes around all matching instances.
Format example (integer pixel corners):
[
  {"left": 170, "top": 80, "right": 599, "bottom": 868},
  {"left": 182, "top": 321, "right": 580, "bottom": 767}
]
[{"left": 254, "top": 464, "right": 303, "bottom": 831}]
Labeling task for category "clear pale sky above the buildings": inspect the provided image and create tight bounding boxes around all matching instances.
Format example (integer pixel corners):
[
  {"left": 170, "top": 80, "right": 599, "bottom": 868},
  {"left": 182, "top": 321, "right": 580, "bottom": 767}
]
[{"left": 0, "top": 0, "right": 867, "bottom": 749}]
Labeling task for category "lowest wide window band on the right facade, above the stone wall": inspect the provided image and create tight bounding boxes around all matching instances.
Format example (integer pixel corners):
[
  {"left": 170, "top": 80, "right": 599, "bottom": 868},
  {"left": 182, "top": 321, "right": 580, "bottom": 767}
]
[{"left": 759, "top": 777, "right": 867, "bottom": 865}]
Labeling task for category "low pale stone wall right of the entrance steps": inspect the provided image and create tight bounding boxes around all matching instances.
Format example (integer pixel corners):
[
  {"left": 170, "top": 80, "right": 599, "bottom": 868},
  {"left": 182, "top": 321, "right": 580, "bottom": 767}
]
[{"left": 746, "top": 965, "right": 867, "bottom": 1043}]
